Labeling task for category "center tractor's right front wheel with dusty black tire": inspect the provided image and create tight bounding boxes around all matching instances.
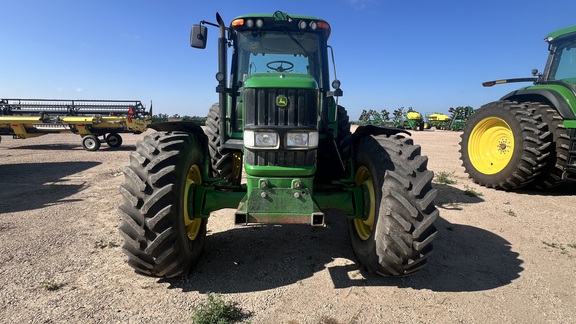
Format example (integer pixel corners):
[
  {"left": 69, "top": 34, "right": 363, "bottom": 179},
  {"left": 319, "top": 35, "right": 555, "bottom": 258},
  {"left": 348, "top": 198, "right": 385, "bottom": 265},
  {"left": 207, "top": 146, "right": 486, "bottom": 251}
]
[{"left": 348, "top": 135, "right": 439, "bottom": 276}]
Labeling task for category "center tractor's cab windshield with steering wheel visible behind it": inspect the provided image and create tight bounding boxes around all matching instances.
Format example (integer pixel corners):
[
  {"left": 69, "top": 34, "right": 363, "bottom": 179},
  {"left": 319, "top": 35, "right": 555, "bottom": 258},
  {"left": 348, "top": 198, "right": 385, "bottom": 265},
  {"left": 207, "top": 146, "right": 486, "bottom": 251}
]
[{"left": 236, "top": 30, "right": 324, "bottom": 84}]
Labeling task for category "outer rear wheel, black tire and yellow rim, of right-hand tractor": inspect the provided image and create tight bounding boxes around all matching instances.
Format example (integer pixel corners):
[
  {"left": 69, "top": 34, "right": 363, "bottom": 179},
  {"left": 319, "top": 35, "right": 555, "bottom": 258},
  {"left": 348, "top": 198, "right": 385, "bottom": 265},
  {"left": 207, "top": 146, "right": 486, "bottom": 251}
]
[{"left": 460, "top": 101, "right": 550, "bottom": 190}]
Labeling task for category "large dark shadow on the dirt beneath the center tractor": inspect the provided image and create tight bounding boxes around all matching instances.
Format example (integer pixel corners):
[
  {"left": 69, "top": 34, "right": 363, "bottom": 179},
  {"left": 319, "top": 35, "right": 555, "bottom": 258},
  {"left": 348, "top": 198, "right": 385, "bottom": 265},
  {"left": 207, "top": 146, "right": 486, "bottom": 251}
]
[{"left": 159, "top": 212, "right": 523, "bottom": 293}]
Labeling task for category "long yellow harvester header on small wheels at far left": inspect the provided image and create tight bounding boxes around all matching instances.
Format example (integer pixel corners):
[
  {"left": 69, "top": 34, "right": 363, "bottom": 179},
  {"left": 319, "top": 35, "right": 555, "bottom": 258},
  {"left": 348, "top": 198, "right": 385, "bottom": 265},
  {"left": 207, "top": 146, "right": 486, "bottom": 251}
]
[{"left": 0, "top": 99, "right": 152, "bottom": 151}]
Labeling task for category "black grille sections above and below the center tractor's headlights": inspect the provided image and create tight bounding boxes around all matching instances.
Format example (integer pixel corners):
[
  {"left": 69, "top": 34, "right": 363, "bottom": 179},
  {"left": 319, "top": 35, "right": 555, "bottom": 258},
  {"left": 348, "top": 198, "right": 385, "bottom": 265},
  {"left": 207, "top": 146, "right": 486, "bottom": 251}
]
[{"left": 244, "top": 88, "right": 318, "bottom": 167}]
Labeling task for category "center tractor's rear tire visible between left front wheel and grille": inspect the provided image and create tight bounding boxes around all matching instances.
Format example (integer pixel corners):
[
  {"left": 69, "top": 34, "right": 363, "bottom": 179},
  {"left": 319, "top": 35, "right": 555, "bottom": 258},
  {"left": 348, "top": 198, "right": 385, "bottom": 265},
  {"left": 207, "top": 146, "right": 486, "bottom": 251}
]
[{"left": 205, "top": 104, "right": 242, "bottom": 185}]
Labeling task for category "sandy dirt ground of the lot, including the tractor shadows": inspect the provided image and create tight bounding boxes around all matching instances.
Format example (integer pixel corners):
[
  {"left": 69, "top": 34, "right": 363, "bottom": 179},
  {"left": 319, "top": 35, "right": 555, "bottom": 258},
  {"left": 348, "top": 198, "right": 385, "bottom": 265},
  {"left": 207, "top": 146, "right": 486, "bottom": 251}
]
[{"left": 0, "top": 131, "right": 576, "bottom": 323}]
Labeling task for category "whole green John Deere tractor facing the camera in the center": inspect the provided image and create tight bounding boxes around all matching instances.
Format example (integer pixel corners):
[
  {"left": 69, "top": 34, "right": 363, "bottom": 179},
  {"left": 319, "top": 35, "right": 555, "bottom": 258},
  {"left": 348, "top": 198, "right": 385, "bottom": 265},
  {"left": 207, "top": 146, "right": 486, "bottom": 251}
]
[{"left": 118, "top": 12, "right": 438, "bottom": 277}]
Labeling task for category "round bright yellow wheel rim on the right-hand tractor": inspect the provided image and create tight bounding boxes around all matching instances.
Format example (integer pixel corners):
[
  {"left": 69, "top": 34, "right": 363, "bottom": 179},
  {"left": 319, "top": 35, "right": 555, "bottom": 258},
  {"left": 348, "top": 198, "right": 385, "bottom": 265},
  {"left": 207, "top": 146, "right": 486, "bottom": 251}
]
[{"left": 468, "top": 117, "right": 514, "bottom": 175}]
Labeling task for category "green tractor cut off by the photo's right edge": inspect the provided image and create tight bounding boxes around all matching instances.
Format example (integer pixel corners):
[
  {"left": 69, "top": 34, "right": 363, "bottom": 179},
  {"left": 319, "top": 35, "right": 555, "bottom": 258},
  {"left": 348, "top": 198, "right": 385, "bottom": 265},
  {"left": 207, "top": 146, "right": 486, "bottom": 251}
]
[{"left": 460, "top": 26, "right": 576, "bottom": 190}]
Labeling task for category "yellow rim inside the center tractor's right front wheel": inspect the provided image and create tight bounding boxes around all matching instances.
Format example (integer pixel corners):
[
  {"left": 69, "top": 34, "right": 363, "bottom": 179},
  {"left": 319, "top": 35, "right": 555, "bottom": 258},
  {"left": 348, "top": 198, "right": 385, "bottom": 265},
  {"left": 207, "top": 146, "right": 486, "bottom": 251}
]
[{"left": 354, "top": 166, "right": 376, "bottom": 241}]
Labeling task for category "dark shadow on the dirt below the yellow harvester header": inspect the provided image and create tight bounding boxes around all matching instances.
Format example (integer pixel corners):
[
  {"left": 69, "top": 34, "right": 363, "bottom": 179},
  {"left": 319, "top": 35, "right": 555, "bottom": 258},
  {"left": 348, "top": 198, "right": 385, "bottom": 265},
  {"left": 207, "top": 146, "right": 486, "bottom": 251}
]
[{"left": 0, "top": 162, "right": 100, "bottom": 214}]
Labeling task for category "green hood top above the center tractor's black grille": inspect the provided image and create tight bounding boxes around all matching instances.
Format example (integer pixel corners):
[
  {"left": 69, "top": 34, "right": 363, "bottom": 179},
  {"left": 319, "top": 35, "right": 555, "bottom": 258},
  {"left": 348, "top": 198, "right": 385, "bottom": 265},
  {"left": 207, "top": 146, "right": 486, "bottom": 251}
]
[{"left": 244, "top": 72, "right": 318, "bottom": 89}]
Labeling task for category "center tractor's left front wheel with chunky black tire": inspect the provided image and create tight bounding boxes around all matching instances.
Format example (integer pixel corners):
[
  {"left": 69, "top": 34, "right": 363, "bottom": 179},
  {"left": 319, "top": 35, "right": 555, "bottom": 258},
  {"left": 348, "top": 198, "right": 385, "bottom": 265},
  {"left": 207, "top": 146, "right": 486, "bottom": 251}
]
[{"left": 118, "top": 132, "right": 207, "bottom": 277}]
